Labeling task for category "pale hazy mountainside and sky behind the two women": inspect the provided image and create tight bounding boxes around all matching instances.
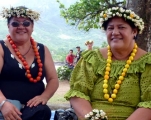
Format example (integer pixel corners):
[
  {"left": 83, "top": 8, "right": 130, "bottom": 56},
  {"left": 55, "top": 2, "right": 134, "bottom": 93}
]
[{"left": 0, "top": 0, "right": 106, "bottom": 61}]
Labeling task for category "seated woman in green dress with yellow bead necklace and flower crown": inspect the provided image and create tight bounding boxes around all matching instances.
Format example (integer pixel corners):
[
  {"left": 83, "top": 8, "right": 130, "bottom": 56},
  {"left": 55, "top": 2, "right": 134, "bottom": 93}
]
[{"left": 65, "top": 7, "right": 151, "bottom": 120}]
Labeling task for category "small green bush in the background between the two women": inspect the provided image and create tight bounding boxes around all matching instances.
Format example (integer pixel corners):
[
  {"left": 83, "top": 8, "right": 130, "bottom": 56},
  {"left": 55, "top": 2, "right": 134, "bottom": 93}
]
[{"left": 57, "top": 66, "right": 72, "bottom": 80}]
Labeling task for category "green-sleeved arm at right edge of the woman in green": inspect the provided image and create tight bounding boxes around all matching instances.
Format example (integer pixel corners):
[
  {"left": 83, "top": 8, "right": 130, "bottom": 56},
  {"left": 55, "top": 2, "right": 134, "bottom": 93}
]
[{"left": 127, "top": 62, "right": 151, "bottom": 120}]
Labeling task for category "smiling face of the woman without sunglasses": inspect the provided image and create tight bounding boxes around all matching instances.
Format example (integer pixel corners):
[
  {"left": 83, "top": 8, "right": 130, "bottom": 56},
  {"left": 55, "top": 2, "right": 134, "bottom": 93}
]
[{"left": 106, "top": 17, "right": 137, "bottom": 49}]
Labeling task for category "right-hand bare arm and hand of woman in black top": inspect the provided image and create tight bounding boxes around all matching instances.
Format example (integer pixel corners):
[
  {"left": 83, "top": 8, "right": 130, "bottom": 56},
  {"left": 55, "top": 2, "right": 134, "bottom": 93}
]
[{"left": 27, "top": 46, "right": 59, "bottom": 107}]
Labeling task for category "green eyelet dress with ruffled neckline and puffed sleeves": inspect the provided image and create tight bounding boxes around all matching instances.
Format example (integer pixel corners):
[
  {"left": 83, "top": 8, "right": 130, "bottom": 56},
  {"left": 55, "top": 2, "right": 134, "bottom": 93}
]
[{"left": 64, "top": 49, "right": 151, "bottom": 120}]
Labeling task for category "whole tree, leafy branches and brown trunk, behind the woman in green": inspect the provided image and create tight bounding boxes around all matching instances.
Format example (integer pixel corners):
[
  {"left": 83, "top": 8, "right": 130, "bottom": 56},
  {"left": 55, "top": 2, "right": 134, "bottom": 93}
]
[{"left": 57, "top": 0, "right": 151, "bottom": 51}]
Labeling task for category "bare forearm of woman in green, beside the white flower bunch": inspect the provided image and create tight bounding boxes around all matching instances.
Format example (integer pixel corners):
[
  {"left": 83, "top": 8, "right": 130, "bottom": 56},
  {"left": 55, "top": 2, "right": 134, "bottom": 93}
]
[{"left": 70, "top": 97, "right": 92, "bottom": 120}]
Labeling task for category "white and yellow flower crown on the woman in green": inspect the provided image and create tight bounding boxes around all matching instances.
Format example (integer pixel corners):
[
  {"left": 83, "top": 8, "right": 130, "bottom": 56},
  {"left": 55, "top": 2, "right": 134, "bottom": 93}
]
[{"left": 100, "top": 7, "right": 144, "bottom": 34}]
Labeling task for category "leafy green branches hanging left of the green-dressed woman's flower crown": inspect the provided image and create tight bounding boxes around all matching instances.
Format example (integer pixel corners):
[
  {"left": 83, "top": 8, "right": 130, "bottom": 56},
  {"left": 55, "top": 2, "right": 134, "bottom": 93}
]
[{"left": 57, "top": 0, "right": 126, "bottom": 31}]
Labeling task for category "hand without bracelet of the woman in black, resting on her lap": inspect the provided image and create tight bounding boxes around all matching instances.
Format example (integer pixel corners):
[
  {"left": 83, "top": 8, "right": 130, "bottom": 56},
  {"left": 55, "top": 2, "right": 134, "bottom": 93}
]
[{"left": 27, "top": 95, "right": 48, "bottom": 107}]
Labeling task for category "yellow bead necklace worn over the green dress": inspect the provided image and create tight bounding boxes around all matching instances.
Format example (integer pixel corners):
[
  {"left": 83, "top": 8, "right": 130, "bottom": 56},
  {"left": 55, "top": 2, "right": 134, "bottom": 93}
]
[{"left": 103, "top": 43, "right": 137, "bottom": 102}]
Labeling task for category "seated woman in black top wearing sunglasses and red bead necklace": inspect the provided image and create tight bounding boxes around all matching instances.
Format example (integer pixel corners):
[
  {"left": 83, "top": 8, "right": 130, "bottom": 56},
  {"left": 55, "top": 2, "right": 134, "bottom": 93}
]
[{"left": 0, "top": 6, "right": 58, "bottom": 120}]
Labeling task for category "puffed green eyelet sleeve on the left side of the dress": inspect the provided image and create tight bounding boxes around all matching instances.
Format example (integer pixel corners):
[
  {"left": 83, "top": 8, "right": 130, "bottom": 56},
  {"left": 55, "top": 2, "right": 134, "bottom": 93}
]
[{"left": 64, "top": 51, "right": 96, "bottom": 101}]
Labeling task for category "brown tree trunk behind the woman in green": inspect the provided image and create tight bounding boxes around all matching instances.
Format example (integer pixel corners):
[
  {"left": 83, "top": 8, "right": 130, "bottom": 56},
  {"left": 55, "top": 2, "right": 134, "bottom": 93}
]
[{"left": 126, "top": 0, "right": 151, "bottom": 52}]
